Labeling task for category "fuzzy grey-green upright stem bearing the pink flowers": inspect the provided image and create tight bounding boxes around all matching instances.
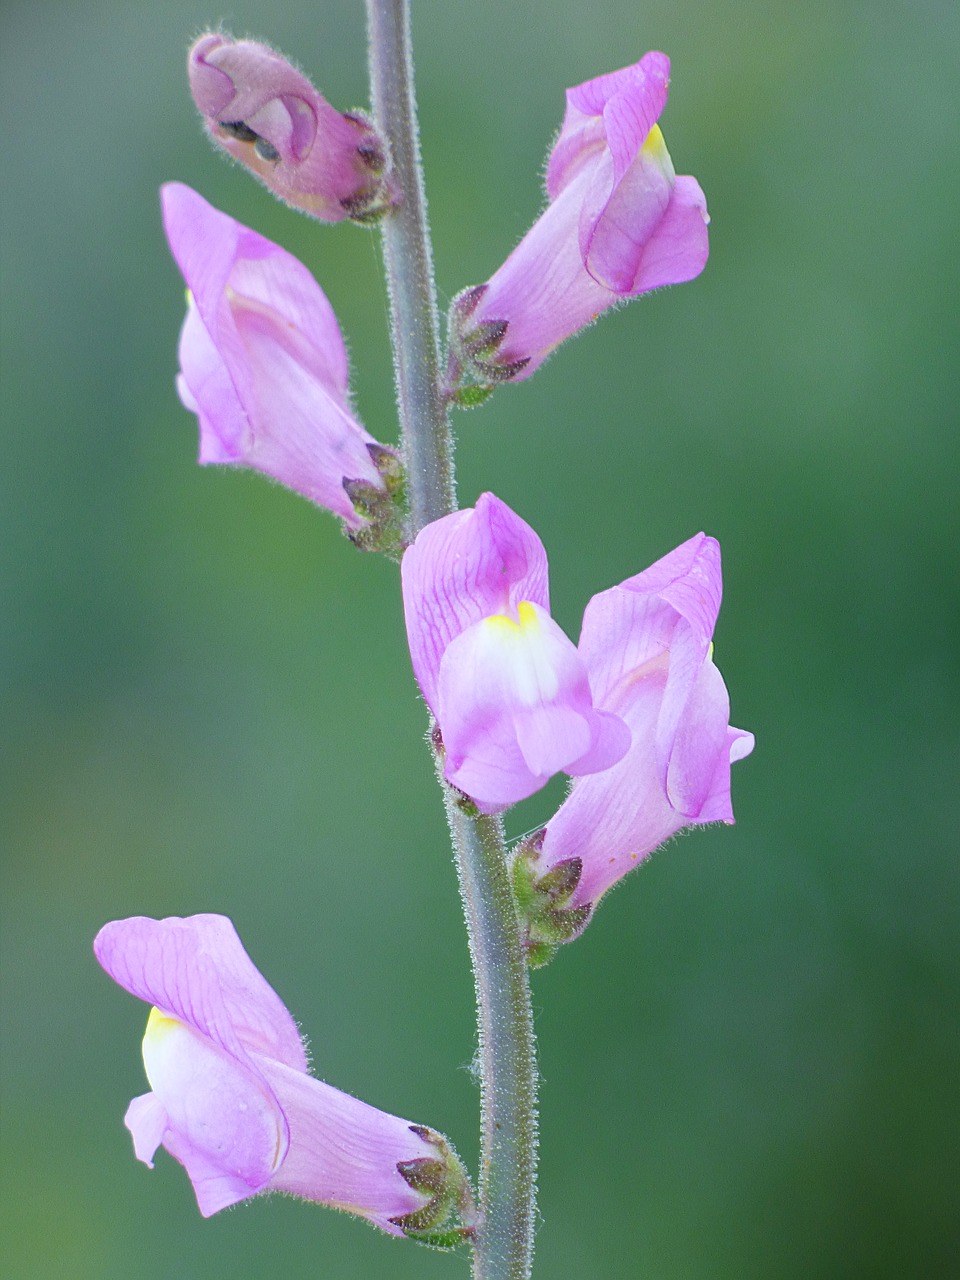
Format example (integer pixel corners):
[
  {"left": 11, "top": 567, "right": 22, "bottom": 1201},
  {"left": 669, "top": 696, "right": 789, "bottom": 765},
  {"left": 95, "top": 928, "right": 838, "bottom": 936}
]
[{"left": 366, "top": 0, "right": 536, "bottom": 1280}]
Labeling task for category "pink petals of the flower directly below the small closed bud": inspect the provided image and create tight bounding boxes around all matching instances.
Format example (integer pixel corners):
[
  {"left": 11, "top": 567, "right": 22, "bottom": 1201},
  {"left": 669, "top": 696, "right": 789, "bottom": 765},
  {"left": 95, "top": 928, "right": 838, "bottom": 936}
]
[{"left": 161, "top": 182, "right": 394, "bottom": 529}]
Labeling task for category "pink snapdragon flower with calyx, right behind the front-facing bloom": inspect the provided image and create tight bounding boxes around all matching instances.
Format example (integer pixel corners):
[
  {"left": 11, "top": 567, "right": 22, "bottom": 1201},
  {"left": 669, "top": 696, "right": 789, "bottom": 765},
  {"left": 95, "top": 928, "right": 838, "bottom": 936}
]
[{"left": 515, "top": 534, "right": 754, "bottom": 960}]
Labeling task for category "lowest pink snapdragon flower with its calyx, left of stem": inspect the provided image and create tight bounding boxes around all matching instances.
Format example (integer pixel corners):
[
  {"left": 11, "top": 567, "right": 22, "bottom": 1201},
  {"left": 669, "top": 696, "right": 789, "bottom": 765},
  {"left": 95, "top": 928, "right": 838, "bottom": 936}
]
[{"left": 93, "top": 915, "right": 468, "bottom": 1235}]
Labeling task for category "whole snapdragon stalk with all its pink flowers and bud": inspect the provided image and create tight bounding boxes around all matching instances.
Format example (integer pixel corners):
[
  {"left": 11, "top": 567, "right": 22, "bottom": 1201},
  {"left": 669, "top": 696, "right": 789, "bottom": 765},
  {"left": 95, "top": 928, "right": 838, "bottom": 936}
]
[{"left": 95, "top": 12, "right": 753, "bottom": 1280}]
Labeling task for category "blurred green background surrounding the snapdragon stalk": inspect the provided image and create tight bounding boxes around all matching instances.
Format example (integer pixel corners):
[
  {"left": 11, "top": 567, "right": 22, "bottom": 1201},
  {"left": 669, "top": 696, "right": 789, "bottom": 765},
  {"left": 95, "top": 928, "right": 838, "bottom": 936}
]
[{"left": 0, "top": 0, "right": 960, "bottom": 1280}]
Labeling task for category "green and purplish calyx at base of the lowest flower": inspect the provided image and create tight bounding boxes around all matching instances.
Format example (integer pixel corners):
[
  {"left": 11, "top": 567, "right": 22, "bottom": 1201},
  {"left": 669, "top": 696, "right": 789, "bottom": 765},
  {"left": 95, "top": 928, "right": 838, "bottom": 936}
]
[{"left": 390, "top": 1125, "right": 476, "bottom": 1249}]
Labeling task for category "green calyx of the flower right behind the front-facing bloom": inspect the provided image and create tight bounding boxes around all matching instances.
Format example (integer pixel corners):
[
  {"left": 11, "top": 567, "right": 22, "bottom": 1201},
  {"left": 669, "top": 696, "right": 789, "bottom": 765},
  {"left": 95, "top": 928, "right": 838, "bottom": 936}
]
[{"left": 511, "top": 831, "right": 593, "bottom": 969}]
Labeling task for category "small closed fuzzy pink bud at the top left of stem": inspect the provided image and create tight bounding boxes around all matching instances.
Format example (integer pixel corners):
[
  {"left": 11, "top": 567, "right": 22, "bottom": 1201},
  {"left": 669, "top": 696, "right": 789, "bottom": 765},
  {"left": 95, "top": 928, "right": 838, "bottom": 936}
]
[{"left": 187, "top": 32, "right": 392, "bottom": 223}]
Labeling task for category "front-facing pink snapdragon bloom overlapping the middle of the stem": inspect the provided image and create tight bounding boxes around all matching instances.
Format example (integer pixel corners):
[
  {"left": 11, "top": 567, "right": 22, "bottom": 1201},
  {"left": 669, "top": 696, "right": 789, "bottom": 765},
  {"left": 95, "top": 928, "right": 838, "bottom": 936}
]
[{"left": 402, "top": 493, "right": 630, "bottom": 812}]
